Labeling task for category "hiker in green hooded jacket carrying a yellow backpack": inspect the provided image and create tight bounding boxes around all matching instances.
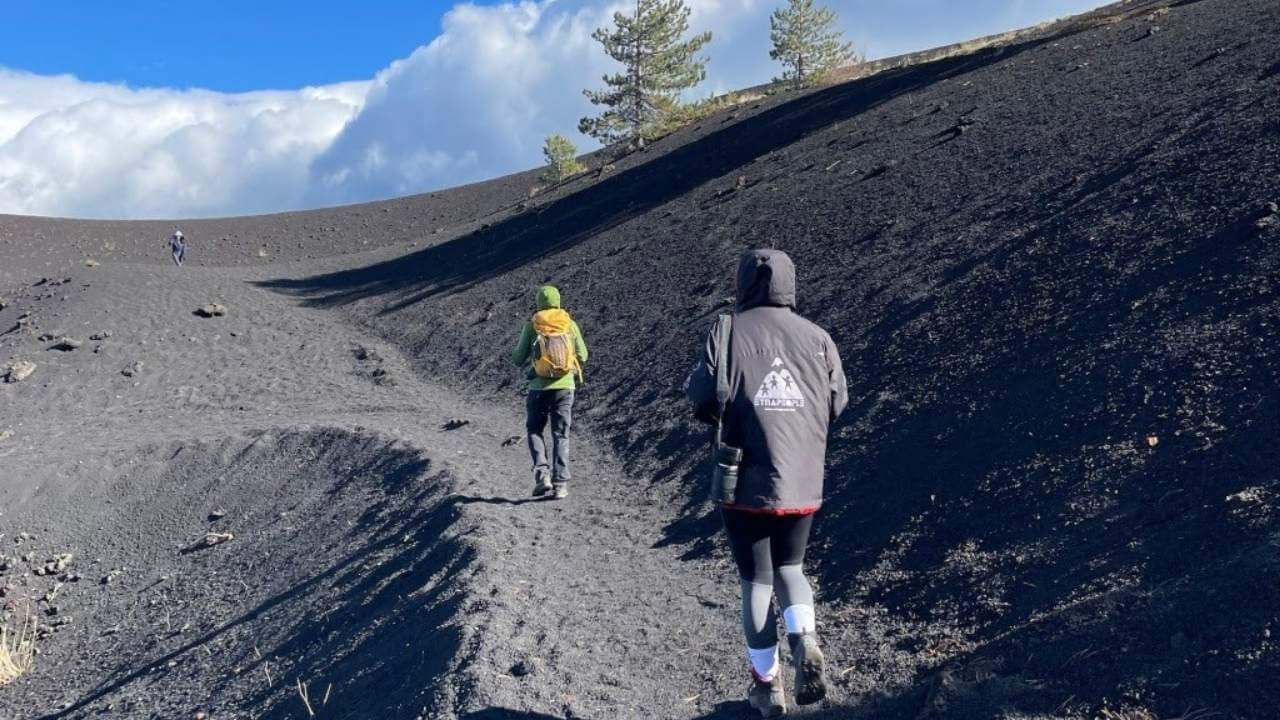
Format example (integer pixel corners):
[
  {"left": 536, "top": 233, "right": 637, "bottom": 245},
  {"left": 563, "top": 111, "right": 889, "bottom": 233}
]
[{"left": 511, "top": 284, "right": 586, "bottom": 500}]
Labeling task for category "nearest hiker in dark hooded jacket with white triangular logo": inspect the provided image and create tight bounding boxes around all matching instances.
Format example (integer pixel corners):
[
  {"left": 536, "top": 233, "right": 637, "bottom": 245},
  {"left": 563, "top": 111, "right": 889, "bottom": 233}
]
[{"left": 687, "top": 250, "right": 849, "bottom": 717}]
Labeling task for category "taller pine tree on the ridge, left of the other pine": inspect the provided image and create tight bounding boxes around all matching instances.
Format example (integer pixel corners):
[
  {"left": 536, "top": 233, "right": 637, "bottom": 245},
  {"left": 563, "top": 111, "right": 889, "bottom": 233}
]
[{"left": 577, "top": 0, "right": 712, "bottom": 146}]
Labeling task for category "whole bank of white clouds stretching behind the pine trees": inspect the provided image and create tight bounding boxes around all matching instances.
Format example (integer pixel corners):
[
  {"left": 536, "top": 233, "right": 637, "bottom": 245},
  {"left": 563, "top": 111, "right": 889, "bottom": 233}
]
[{"left": 0, "top": 0, "right": 1096, "bottom": 218}]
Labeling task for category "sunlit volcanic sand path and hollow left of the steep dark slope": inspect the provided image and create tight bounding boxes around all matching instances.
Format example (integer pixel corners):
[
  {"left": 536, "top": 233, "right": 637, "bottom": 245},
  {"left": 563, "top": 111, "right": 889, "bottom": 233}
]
[{"left": 0, "top": 263, "right": 745, "bottom": 717}]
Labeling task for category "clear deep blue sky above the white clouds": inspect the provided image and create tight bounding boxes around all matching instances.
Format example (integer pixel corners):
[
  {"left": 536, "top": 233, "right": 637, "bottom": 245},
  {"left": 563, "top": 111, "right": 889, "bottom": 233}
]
[{"left": 0, "top": 0, "right": 453, "bottom": 92}]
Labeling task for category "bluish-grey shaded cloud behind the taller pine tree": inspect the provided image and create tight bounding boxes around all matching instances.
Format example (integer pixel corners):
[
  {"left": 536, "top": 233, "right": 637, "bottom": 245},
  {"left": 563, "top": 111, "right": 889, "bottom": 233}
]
[{"left": 310, "top": 0, "right": 772, "bottom": 205}]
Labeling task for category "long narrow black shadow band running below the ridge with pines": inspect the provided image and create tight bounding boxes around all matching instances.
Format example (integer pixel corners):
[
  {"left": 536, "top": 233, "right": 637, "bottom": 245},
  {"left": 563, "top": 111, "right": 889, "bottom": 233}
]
[{"left": 259, "top": 34, "right": 1064, "bottom": 308}]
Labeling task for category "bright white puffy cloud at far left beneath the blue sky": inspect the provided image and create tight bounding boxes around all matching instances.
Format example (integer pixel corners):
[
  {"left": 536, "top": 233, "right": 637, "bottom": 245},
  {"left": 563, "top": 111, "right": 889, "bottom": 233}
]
[{"left": 0, "top": 69, "right": 367, "bottom": 218}]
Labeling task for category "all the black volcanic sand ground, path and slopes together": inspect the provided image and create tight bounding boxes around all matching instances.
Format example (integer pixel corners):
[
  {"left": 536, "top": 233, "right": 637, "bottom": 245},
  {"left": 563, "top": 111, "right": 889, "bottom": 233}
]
[{"left": 0, "top": 0, "right": 1280, "bottom": 719}]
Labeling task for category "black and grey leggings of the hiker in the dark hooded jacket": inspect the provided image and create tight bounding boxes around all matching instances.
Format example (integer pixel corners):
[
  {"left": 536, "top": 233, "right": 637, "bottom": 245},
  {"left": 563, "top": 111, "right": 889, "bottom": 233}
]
[{"left": 721, "top": 509, "right": 813, "bottom": 650}]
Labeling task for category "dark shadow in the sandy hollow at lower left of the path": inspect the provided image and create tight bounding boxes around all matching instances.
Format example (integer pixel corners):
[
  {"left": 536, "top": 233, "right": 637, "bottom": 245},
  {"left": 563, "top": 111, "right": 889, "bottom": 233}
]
[{"left": 41, "top": 438, "right": 475, "bottom": 720}]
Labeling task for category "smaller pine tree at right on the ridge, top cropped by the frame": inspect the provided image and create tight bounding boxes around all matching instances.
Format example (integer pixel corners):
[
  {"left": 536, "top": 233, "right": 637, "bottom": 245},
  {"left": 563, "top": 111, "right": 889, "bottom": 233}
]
[{"left": 769, "top": 0, "right": 860, "bottom": 86}]
